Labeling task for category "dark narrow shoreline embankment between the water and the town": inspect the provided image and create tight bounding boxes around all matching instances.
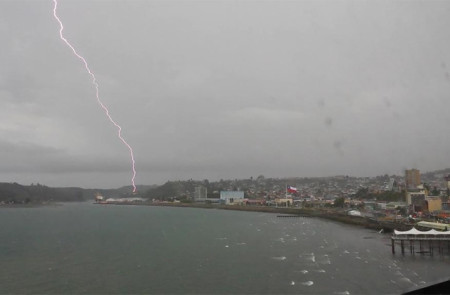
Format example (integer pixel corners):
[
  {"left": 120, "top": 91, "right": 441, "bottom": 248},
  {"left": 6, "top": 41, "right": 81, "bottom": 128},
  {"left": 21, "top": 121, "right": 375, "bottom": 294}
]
[{"left": 111, "top": 203, "right": 413, "bottom": 232}]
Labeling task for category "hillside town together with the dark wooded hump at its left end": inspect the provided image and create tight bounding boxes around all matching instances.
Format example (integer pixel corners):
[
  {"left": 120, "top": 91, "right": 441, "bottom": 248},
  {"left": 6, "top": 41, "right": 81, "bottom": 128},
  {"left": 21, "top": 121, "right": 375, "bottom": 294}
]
[{"left": 140, "top": 169, "right": 450, "bottom": 227}]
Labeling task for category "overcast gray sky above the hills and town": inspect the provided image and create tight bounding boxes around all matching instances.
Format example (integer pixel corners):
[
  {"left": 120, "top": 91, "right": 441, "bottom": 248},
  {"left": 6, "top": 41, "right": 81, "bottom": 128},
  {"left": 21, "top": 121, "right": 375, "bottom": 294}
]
[{"left": 0, "top": 0, "right": 450, "bottom": 188}]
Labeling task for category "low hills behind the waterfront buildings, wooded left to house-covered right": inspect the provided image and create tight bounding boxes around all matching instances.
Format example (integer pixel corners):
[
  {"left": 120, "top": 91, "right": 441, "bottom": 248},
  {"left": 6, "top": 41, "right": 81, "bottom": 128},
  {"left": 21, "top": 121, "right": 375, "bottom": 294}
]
[{"left": 0, "top": 169, "right": 450, "bottom": 204}]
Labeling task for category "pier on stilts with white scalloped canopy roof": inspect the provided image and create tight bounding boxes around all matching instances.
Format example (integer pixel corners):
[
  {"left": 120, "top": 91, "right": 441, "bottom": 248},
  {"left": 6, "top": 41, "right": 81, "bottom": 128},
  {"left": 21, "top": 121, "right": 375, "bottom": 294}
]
[{"left": 391, "top": 228, "right": 450, "bottom": 255}]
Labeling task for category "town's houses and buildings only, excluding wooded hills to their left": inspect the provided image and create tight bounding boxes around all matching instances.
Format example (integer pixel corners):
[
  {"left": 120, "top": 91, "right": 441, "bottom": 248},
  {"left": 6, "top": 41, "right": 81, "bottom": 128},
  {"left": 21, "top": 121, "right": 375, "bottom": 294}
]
[{"left": 189, "top": 169, "right": 450, "bottom": 218}]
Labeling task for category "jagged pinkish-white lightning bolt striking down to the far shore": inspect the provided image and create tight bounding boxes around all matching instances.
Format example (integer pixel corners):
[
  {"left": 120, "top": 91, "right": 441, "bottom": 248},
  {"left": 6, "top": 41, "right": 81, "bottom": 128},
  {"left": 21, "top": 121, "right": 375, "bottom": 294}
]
[{"left": 53, "top": 0, "right": 136, "bottom": 193}]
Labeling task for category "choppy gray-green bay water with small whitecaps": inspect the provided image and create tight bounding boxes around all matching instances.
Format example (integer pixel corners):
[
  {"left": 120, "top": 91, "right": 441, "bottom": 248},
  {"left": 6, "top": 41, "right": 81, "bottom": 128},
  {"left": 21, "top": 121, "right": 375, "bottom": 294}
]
[{"left": 0, "top": 203, "right": 450, "bottom": 294}]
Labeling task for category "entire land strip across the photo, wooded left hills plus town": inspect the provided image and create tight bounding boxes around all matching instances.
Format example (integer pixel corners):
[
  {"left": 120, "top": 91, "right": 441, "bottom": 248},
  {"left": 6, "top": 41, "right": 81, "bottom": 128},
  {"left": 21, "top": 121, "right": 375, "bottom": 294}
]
[{"left": 0, "top": 169, "right": 450, "bottom": 227}]
